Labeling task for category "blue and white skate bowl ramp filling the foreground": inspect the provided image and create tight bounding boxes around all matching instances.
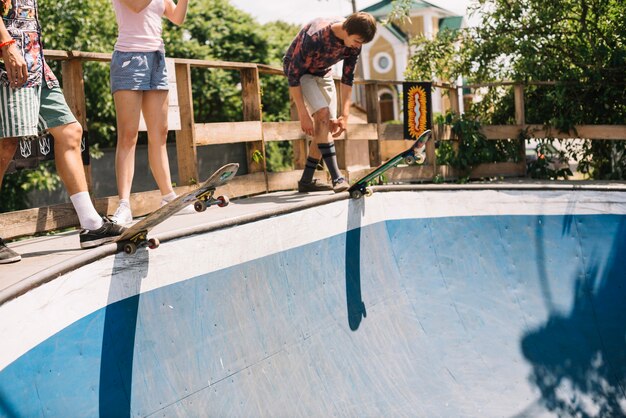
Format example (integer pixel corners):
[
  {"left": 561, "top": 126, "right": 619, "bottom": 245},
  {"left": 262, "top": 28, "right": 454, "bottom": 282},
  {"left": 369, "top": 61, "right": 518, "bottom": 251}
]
[{"left": 0, "top": 190, "right": 626, "bottom": 417}]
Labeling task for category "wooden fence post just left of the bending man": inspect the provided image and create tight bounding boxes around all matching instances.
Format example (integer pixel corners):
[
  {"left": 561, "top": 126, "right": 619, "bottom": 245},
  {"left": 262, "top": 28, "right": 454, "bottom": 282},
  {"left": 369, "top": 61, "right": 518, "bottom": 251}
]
[{"left": 240, "top": 67, "right": 267, "bottom": 185}]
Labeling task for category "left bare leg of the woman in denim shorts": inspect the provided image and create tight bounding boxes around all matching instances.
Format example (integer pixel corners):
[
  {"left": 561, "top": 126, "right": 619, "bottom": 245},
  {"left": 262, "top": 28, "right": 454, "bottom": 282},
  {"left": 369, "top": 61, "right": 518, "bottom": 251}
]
[{"left": 113, "top": 90, "right": 144, "bottom": 200}]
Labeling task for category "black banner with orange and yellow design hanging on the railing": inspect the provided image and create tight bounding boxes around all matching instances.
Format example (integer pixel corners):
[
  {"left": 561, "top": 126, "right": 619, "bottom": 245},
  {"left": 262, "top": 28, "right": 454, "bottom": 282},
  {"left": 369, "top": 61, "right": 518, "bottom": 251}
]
[{"left": 402, "top": 82, "right": 433, "bottom": 139}]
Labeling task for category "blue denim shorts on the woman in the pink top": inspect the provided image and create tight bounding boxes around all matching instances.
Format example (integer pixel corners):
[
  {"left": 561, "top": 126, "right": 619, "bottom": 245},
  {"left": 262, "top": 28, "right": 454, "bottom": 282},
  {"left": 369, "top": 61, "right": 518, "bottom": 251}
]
[{"left": 111, "top": 51, "right": 169, "bottom": 93}]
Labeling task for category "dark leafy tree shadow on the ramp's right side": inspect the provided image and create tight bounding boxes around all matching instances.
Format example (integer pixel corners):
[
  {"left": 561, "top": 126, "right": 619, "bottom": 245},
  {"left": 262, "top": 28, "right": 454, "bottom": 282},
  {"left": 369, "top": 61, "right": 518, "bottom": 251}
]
[{"left": 521, "top": 217, "right": 626, "bottom": 417}]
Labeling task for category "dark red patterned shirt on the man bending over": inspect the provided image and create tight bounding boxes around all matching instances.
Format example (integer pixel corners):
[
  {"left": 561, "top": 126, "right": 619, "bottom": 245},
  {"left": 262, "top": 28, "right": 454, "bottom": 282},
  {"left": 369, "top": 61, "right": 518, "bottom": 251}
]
[{"left": 283, "top": 18, "right": 361, "bottom": 87}]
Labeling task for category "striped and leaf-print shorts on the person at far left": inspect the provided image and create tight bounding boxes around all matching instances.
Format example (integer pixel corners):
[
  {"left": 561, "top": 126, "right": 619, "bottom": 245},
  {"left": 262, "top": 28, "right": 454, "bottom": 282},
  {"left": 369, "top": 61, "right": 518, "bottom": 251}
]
[{"left": 0, "top": 82, "right": 76, "bottom": 139}]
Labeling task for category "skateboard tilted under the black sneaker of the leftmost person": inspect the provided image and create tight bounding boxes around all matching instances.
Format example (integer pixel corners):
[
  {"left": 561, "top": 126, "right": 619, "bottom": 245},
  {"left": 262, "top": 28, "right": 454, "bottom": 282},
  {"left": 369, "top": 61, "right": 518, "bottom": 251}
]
[{"left": 114, "top": 164, "right": 239, "bottom": 255}]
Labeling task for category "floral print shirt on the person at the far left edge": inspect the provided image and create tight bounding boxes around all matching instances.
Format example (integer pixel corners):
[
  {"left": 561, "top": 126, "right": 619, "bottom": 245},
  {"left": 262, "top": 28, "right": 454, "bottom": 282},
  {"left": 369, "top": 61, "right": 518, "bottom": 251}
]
[{"left": 0, "top": 0, "right": 59, "bottom": 88}]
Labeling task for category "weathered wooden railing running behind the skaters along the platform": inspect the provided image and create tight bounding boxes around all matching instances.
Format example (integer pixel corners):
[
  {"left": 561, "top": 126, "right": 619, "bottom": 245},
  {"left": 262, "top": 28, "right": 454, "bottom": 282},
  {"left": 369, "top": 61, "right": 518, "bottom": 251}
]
[{"left": 0, "top": 51, "right": 626, "bottom": 239}]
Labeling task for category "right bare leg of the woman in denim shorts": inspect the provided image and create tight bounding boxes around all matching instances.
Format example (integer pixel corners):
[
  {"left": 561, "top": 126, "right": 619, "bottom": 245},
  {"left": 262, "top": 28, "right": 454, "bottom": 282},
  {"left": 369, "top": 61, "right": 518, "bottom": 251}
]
[{"left": 142, "top": 90, "right": 174, "bottom": 196}]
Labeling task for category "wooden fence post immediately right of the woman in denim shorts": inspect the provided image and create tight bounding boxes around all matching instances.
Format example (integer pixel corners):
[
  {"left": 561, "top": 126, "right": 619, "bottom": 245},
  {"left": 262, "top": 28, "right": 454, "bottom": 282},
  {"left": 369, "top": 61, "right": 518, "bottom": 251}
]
[{"left": 175, "top": 64, "right": 197, "bottom": 186}]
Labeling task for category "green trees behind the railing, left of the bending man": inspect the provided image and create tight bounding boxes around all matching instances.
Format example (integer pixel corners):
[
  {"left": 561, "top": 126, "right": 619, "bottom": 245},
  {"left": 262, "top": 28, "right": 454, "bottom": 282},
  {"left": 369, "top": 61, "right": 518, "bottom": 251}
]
[{"left": 0, "top": 0, "right": 299, "bottom": 211}]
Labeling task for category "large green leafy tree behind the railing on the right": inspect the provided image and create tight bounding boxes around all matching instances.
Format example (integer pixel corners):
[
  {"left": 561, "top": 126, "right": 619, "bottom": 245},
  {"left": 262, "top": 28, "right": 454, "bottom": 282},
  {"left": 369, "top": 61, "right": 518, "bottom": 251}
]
[{"left": 407, "top": 0, "right": 626, "bottom": 179}]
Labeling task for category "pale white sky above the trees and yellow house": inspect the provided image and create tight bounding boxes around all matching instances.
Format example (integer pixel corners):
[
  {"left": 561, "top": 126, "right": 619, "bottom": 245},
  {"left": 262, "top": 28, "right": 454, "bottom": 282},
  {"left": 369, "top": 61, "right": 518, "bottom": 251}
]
[{"left": 231, "top": 0, "right": 470, "bottom": 24}]
